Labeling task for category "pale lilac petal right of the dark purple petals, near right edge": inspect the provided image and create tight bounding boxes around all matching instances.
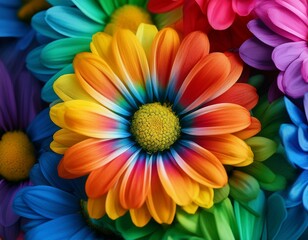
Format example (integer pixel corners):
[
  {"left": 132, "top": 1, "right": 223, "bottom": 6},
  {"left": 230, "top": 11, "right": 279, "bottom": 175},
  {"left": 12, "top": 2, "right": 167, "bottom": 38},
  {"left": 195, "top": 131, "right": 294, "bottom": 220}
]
[{"left": 272, "top": 41, "right": 307, "bottom": 71}]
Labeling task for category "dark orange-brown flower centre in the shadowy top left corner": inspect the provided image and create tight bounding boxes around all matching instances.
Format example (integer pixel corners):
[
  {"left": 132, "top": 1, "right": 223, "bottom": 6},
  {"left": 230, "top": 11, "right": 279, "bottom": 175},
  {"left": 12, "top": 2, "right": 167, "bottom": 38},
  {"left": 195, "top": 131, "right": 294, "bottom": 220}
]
[{"left": 17, "top": 0, "right": 51, "bottom": 21}]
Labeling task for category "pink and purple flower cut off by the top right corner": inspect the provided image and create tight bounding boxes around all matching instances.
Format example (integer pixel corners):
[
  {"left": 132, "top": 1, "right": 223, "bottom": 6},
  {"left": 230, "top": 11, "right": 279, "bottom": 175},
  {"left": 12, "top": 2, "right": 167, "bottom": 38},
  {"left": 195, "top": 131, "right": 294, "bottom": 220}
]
[{"left": 240, "top": 0, "right": 308, "bottom": 98}]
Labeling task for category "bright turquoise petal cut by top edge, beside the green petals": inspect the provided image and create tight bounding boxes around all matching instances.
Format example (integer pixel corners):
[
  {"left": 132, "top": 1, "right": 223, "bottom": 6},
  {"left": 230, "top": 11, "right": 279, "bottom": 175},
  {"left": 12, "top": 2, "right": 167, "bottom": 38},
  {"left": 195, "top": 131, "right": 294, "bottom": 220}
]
[{"left": 72, "top": 0, "right": 108, "bottom": 23}]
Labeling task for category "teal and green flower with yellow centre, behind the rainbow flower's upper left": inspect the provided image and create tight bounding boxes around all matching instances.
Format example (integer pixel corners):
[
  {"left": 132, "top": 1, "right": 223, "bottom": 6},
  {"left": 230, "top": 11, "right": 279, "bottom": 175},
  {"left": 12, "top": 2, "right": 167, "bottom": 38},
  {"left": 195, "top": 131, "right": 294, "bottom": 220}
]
[{"left": 27, "top": 0, "right": 179, "bottom": 102}]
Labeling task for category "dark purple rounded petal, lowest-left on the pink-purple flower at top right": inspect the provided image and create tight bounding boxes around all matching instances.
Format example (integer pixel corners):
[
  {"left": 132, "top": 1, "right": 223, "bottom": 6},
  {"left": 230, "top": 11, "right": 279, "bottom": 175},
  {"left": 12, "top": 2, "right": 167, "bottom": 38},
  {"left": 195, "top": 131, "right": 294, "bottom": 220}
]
[{"left": 239, "top": 38, "right": 276, "bottom": 70}]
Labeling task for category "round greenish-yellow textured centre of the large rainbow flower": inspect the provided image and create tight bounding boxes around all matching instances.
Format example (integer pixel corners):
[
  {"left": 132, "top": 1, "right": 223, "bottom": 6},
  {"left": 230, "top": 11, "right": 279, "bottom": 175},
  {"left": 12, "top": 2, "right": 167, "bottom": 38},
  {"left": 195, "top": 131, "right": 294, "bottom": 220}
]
[{"left": 131, "top": 102, "right": 181, "bottom": 153}]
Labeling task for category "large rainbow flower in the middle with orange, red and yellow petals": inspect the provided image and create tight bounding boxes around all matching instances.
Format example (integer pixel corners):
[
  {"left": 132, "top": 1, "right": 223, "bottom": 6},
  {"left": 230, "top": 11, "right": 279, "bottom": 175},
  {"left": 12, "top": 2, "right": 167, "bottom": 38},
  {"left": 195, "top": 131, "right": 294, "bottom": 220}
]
[{"left": 50, "top": 24, "right": 260, "bottom": 226}]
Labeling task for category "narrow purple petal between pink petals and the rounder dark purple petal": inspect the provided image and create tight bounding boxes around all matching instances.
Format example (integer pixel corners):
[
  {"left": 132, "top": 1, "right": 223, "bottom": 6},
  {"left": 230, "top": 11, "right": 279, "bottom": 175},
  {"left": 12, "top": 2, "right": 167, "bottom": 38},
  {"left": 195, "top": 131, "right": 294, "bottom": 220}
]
[{"left": 247, "top": 19, "right": 289, "bottom": 47}]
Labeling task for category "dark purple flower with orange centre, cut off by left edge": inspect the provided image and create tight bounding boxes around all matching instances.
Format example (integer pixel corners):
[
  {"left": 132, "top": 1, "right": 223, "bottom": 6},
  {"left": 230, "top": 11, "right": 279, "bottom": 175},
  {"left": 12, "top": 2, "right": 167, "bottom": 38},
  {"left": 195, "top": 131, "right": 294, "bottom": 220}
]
[{"left": 0, "top": 54, "right": 56, "bottom": 239}]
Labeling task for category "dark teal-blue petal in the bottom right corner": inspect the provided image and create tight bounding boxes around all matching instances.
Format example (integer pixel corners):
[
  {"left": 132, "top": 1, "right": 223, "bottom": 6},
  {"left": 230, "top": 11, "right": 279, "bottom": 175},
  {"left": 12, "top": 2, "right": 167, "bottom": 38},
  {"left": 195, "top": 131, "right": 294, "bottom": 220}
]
[{"left": 270, "top": 205, "right": 308, "bottom": 240}]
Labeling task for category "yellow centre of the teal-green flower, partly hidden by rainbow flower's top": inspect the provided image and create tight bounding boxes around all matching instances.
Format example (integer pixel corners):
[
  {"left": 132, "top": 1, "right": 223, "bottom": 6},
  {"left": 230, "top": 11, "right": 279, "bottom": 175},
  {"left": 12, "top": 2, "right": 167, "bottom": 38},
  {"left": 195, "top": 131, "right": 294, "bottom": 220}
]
[{"left": 104, "top": 5, "right": 152, "bottom": 35}]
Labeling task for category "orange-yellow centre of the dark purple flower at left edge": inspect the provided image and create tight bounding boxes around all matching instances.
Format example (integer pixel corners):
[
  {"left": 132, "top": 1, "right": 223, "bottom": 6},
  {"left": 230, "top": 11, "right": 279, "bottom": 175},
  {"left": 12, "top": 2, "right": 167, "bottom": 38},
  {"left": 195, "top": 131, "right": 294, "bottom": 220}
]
[{"left": 0, "top": 131, "right": 36, "bottom": 182}]
